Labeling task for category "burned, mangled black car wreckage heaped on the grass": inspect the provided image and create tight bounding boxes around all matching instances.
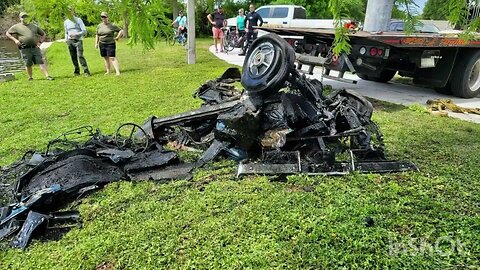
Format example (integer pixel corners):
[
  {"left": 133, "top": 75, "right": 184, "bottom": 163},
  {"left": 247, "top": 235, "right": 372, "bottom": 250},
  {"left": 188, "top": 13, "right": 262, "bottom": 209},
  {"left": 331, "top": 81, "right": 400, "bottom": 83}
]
[{"left": 0, "top": 34, "right": 416, "bottom": 249}]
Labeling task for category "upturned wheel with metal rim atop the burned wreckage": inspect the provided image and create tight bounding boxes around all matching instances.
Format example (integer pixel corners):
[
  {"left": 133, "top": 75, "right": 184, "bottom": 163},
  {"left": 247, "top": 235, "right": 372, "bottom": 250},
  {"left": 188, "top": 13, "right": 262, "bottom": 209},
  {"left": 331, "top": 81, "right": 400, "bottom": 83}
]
[{"left": 241, "top": 34, "right": 295, "bottom": 92}]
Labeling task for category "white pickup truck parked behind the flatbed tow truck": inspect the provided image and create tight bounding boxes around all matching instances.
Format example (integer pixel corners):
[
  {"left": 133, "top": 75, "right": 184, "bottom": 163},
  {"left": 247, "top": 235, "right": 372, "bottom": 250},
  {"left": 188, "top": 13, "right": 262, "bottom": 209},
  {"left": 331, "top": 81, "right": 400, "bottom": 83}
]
[{"left": 227, "top": 5, "right": 335, "bottom": 30}]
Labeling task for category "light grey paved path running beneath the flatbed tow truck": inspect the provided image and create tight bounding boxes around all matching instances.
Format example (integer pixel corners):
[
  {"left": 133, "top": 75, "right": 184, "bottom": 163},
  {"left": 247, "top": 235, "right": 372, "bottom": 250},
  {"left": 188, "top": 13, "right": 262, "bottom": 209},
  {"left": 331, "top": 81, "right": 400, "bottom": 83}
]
[{"left": 210, "top": 46, "right": 480, "bottom": 123}]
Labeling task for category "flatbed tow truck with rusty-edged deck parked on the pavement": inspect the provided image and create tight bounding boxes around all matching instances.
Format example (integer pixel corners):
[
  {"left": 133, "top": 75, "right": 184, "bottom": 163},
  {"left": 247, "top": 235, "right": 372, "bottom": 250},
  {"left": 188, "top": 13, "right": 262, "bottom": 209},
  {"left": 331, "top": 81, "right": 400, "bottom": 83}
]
[{"left": 259, "top": 27, "right": 480, "bottom": 98}]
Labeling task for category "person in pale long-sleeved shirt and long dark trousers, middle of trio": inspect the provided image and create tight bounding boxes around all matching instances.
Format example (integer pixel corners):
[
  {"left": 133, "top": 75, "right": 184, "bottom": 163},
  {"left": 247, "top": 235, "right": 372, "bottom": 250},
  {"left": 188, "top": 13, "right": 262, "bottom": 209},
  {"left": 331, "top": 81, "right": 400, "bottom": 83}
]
[{"left": 63, "top": 9, "right": 90, "bottom": 77}]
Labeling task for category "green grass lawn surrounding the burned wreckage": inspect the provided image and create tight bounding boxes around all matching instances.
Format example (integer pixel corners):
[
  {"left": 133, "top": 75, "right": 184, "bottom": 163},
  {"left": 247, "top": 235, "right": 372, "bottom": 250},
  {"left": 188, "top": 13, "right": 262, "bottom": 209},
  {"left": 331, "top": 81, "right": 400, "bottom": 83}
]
[{"left": 0, "top": 40, "right": 480, "bottom": 269}]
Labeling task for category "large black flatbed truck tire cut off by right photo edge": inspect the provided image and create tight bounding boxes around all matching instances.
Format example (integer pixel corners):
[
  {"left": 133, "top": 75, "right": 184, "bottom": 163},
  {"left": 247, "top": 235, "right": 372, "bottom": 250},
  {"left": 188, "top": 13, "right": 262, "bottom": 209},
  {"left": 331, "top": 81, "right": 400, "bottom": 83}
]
[{"left": 450, "top": 50, "right": 480, "bottom": 98}]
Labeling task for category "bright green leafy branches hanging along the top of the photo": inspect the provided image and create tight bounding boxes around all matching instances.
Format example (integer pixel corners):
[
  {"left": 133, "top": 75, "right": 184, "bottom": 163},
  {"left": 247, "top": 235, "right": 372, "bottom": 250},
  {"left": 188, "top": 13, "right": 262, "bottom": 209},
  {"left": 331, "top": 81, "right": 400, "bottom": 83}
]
[{"left": 0, "top": 0, "right": 480, "bottom": 53}]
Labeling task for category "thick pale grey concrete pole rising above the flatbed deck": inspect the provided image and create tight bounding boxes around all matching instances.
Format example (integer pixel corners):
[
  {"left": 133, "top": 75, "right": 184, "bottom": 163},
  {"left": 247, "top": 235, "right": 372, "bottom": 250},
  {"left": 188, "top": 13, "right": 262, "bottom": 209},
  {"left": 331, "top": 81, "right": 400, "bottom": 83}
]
[{"left": 363, "top": 0, "right": 395, "bottom": 32}]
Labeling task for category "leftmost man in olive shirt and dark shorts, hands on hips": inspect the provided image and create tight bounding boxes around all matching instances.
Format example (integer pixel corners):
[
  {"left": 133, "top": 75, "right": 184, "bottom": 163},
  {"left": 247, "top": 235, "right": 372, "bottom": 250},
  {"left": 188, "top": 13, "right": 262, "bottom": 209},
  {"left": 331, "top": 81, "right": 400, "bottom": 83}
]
[{"left": 6, "top": 12, "right": 53, "bottom": 81}]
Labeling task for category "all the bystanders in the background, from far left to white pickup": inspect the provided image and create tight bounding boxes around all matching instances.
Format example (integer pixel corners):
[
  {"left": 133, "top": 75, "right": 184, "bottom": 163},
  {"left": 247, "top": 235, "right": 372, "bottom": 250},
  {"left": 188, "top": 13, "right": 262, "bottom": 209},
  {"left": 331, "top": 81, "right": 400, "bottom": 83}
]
[{"left": 6, "top": 4, "right": 263, "bottom": 80}]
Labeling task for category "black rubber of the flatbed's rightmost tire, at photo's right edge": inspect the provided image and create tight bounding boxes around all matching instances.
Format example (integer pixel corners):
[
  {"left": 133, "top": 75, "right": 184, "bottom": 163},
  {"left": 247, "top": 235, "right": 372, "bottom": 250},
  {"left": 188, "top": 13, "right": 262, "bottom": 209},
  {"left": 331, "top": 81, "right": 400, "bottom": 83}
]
[{"left": 450, "top": 50, "right": 480, "bottom": 98}]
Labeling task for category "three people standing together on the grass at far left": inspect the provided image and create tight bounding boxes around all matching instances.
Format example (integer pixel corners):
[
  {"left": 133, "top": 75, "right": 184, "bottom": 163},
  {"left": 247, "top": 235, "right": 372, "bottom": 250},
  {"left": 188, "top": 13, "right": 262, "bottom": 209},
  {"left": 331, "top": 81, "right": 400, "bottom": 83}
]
[{"left": 6, "top": 9, "right": 123, "bottom": 80}]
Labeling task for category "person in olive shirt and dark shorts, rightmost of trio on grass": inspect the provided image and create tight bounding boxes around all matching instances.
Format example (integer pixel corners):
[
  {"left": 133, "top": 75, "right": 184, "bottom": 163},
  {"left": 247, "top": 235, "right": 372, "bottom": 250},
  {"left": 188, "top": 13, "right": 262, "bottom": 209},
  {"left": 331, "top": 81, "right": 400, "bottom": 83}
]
[{"left": 95, "top": 11, "right": 123, "bottom": 76}]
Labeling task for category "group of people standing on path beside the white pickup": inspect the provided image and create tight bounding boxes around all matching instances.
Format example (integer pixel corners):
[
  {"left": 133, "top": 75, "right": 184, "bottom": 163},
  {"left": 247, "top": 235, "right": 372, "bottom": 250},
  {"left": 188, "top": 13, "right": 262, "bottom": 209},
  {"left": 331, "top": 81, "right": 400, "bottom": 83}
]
[{"left": 207, "top": 4, "right": 263, "bottom": 55}]
